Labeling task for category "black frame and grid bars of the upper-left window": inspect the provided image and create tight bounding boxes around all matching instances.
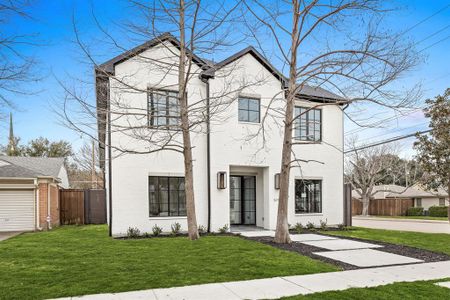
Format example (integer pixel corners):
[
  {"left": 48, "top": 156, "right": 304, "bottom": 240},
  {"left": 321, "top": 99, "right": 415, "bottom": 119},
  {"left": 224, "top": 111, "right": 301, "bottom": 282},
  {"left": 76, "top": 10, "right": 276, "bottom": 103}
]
[{"left": 147, "top": 87, "right": 182, "bottom": 130}]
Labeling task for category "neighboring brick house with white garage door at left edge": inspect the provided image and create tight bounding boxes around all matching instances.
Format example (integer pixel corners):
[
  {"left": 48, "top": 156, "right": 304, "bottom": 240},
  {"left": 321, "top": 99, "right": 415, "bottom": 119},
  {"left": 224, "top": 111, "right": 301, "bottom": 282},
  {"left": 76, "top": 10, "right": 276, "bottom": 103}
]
[{"left": 0, "top": 156, "right": 69, "bottom": 231}]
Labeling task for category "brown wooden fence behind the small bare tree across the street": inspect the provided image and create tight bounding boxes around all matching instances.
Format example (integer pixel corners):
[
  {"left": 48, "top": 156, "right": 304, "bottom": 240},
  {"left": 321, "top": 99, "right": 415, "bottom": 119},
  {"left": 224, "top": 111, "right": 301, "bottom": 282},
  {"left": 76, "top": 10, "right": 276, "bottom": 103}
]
[{"left": 352, "top": 199, "right": 414, "bottom": 216}]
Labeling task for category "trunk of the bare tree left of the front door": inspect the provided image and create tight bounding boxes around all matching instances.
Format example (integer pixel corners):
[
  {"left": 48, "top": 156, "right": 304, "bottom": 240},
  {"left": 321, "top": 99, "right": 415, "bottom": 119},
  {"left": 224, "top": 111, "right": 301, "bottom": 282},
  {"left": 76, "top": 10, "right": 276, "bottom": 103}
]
[{"left": 178, "top": 0, "right": 199, "bottom": 240}]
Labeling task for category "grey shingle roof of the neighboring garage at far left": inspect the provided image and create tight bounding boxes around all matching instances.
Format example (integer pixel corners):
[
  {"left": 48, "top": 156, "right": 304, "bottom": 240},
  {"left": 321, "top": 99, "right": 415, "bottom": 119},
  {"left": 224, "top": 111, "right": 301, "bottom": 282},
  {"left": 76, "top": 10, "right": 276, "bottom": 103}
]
[{"left": 0, "top": 156, "right": 64, "bottom": 178}]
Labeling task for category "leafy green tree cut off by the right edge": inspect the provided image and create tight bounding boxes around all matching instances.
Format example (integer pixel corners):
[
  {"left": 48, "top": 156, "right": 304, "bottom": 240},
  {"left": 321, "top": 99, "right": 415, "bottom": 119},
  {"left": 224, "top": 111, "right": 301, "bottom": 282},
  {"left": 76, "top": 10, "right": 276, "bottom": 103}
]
[{"left": 414, "top": 89, "right": 450, "bottom": 222}]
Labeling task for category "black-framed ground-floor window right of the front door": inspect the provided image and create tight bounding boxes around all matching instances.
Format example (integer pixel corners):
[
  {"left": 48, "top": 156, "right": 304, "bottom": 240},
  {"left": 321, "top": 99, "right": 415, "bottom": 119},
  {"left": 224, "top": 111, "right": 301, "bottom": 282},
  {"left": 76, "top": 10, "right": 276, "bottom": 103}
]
[{"left": 295, "top": 179, "right": 322, "bottom": 214}]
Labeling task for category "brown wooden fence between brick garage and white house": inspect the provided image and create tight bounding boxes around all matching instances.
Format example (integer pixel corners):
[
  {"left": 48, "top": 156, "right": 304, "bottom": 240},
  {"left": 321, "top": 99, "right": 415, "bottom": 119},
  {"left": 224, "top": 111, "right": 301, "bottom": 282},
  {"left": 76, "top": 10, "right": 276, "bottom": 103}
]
[{"left": 59, "top": 189, "right": 106, "bottom": 225}]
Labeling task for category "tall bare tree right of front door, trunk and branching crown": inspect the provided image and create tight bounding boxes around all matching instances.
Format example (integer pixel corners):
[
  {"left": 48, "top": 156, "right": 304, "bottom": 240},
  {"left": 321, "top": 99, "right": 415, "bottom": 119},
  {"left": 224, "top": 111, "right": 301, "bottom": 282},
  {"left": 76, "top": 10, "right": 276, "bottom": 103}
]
[{"left": 243, "top": 0, "right": 417, "bottom": 243}]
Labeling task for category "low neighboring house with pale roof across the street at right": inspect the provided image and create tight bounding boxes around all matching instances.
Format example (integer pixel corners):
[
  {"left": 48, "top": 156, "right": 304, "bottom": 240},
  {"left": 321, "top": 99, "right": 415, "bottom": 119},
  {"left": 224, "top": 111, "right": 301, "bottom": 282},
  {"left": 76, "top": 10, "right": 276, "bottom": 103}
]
[{"left": 352, "top": 184, "right": 449, "bottom": 215}]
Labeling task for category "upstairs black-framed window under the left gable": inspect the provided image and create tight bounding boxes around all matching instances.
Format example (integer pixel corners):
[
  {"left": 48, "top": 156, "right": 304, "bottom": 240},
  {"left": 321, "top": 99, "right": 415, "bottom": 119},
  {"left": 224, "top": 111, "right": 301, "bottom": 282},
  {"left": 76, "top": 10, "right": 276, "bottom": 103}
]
[{"left": 148, "top": 90, "right": 180, "bottom": 128}]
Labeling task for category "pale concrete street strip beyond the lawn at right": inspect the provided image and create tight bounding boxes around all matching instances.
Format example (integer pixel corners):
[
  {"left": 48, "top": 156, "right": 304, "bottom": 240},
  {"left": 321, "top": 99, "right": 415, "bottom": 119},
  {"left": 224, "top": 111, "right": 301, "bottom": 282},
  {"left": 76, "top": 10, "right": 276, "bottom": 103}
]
[{"left": 352, "top": 216, "right": 450, "bottom": 234}]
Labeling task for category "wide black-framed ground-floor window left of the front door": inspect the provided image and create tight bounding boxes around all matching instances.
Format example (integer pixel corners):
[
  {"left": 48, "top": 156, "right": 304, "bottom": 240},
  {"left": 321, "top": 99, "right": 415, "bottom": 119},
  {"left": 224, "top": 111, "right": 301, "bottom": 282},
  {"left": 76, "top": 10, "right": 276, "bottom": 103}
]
[{"left": 148, "top": 176, "right": 186, "bottom": 217}]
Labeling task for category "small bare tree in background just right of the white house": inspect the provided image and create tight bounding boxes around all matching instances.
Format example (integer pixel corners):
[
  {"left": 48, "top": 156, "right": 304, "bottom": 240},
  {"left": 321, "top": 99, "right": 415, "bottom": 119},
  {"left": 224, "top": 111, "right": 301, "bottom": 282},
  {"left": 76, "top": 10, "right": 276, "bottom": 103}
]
[{"left": 345, "top": 139, "right": 407, "bottom": 216}]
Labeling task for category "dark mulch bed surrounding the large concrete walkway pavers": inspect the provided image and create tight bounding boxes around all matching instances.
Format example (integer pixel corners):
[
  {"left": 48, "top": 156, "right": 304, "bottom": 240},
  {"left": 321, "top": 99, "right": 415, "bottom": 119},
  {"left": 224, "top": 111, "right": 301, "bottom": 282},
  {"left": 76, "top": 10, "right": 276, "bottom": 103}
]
[{"left": 243, "top": 231, "right": 450, "bottom": 270}]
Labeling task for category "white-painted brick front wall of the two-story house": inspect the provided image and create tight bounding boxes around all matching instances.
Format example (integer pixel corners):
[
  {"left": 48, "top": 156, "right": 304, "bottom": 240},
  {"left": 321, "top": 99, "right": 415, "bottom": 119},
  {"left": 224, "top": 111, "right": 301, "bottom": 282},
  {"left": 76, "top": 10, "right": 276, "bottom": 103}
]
[{"left": 111, "top": 43, "right": 343, "bottom": 235}]
